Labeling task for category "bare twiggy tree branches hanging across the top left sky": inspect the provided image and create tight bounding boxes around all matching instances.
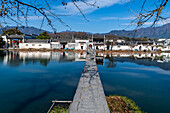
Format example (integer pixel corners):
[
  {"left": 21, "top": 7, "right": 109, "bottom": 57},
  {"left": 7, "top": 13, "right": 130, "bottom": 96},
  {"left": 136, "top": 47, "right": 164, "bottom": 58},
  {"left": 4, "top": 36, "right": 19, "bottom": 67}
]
[{"left": 0, "top": 0, "right": 96, "bottom": 31}]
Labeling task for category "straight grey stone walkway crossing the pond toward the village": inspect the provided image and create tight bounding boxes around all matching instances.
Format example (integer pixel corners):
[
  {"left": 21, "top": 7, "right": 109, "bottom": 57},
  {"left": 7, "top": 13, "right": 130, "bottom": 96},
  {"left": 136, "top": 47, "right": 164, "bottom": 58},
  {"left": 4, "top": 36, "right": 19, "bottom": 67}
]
[{"left": 68, "top": 50, "right": 110, "bottom": 113}]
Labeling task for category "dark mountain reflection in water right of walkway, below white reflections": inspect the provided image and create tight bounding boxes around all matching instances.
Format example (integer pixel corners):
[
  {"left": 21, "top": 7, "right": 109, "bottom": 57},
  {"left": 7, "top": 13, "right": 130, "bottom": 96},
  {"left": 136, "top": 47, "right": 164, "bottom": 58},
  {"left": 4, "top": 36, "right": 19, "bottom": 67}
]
[{"left": 111, "top": 58, "right": 170, "bottom": 70}]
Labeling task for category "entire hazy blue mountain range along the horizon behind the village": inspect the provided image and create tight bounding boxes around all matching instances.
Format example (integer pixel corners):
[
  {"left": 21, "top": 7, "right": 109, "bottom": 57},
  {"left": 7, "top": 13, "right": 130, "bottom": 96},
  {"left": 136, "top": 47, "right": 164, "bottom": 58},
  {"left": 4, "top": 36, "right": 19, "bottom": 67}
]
[{"left": 0, "top": 23, "right": 170, "bottom": 39}]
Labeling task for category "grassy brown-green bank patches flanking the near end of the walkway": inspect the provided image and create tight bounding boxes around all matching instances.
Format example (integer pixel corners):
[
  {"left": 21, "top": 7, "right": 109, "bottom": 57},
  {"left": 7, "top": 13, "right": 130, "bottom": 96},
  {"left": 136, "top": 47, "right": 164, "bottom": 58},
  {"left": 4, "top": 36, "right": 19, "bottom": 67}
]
[{"left": 50, "top": 95, "right": 146, "bottom": 113}]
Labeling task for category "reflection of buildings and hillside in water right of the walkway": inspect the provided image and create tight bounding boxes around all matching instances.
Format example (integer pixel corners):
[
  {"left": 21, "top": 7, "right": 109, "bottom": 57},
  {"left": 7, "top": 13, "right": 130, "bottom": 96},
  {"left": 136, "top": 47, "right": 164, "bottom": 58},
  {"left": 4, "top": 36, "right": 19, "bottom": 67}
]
[{"left": 96, "top": 53, "right": 170, "bottom": 70}]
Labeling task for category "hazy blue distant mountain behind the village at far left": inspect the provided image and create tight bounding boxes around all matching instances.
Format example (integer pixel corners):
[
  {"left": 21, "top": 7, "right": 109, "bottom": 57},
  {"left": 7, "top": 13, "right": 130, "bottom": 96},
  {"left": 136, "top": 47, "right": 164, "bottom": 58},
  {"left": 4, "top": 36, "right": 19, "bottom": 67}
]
[{"left": 0, "top": 26, "right": 50, "bottom": 35}]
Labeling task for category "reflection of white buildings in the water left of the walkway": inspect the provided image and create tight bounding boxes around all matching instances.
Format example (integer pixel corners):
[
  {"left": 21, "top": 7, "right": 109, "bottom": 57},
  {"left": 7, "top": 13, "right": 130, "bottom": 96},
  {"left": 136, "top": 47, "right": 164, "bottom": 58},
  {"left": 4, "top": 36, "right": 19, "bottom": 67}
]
[{"left": 0, "top": 51, "right": 86, "bottom": 67}]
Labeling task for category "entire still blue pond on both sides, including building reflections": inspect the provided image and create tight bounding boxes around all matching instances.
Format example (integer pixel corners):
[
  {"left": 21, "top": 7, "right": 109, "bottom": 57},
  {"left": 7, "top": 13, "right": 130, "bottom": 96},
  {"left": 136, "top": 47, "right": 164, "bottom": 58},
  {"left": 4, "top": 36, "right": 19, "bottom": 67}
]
[{"left": 0, "top": 51, "right": 170, "bottom": 113}]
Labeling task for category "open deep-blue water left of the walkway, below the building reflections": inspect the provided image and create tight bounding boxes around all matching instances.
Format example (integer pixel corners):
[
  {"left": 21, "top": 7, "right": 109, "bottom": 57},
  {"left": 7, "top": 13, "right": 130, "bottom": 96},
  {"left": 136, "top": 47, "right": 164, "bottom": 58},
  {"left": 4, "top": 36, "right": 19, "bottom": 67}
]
[{"left": 0, "top": 53, "right": 84, "bottom": 113}]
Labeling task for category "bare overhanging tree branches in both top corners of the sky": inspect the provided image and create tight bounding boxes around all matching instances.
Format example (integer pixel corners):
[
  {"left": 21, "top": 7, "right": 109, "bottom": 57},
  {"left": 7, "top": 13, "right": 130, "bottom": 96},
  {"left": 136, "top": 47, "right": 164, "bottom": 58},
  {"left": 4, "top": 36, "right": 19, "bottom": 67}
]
[{"left": 0, "top": 0, "right": 168, "bottom": 31}]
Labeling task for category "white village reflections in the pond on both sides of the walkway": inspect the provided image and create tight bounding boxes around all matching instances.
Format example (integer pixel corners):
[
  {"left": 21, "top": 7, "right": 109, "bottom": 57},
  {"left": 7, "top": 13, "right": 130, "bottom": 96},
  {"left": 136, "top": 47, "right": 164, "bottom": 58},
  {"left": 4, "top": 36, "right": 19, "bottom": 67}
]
[{"left": 0, "top": 51, "right": 170, "bottom": 70}]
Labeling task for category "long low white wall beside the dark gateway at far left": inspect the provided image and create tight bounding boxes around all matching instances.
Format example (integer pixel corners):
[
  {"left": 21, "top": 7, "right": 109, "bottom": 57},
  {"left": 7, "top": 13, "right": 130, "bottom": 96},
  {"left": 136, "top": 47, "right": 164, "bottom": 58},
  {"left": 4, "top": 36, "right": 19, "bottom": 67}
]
[{"left": 19, "top": 43, "right": 51, "bottom": 49}]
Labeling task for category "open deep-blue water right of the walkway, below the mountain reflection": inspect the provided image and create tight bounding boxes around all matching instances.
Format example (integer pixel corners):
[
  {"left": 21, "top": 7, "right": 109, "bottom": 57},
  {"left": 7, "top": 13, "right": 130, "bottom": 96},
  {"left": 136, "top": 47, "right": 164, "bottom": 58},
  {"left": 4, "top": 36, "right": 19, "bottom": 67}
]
[{"left": 98, "top": 61, "right": 170, "bottom": 113}]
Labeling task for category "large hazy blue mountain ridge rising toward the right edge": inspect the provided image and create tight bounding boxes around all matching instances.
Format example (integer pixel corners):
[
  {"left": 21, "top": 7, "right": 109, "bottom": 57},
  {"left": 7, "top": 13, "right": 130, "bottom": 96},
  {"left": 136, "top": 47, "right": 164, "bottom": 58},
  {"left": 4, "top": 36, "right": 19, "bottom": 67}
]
[{"left": 105, "top": 23, "right": 170, "bottom": 38}]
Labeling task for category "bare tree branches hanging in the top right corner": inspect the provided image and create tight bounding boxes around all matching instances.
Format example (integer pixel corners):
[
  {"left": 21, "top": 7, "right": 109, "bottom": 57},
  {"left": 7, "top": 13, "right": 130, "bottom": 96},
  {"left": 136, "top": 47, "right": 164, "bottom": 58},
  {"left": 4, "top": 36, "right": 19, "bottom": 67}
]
[{"left": 131, "top": 0, "right": 169, "bottom": 28}]
